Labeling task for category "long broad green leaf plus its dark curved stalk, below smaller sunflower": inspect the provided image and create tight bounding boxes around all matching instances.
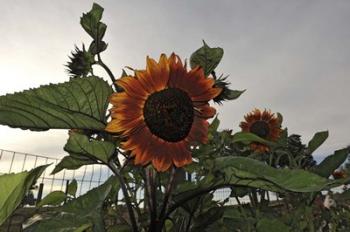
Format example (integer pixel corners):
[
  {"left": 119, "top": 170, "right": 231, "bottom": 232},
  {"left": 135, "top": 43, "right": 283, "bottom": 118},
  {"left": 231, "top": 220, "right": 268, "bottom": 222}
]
[{"left": 171, "top": 156, "right": 343, "bottom": 210}]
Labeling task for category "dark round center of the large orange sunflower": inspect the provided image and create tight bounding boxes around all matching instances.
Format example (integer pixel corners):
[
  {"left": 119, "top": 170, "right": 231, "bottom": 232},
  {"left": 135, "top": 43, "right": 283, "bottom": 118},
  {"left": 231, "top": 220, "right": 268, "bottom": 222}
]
[{"left": 143, "top": 88, "right": 194, "bottom": 142}]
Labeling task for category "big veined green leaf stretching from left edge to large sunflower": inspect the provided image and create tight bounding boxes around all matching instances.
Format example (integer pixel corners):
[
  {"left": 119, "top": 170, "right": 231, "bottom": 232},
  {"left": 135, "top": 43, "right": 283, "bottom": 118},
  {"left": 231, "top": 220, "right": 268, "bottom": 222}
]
[{"left": 0, "top": 76, "right": 112, "bottom": 130}]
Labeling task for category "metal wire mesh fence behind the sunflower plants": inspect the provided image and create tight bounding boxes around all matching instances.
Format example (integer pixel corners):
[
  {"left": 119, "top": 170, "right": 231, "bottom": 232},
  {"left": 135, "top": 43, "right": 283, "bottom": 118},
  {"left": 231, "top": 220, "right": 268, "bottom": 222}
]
[{"left": 0, "top": 149, "right": 264, "bottom": 204}]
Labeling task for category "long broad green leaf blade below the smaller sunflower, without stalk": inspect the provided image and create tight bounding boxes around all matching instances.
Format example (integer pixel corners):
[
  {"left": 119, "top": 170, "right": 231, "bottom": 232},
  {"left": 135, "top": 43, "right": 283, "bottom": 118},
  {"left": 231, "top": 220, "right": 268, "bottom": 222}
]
[{"left": 215, "top": 157, "right": 333, "bottom": 192}]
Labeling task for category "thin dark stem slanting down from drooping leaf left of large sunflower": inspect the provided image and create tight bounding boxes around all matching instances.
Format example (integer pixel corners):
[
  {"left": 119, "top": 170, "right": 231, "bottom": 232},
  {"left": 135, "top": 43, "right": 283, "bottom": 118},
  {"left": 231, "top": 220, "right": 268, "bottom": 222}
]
[{"left": 108, "top": 161, "right": 139, "bottom": 232}]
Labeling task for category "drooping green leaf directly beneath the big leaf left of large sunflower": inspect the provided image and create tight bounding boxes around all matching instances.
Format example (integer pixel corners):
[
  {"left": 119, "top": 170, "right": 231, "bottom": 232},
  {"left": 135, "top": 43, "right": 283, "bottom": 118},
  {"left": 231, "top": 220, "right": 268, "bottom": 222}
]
[{"left": 52, "top": 133, "right": 115, "bottom": 174}]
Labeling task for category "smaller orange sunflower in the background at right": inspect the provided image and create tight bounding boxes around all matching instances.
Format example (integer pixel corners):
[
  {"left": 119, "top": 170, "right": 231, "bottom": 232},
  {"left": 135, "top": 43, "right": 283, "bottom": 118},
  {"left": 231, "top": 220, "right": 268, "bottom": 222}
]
[{"left": 239, "top": 109, "right": 282, "bottom": 153}]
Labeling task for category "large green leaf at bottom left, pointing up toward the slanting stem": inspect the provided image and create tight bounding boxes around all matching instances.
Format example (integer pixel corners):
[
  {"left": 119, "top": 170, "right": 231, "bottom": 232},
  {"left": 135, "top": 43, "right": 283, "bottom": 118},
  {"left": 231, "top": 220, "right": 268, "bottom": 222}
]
[{"left": 25, "top": 177, "right": 118, "bottom": 232}]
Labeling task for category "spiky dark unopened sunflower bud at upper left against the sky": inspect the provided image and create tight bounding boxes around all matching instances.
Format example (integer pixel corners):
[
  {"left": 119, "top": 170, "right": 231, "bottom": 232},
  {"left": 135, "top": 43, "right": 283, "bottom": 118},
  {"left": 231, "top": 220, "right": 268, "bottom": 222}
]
[{"left": 66, "top": 45, "right": 94, "bottom": 78}]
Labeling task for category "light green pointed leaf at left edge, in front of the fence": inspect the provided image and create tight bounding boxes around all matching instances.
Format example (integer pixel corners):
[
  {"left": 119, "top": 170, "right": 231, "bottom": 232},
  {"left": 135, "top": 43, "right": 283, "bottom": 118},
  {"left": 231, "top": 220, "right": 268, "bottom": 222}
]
[{"left": 0, "top": 165, "right": 48, "bottom": 225}]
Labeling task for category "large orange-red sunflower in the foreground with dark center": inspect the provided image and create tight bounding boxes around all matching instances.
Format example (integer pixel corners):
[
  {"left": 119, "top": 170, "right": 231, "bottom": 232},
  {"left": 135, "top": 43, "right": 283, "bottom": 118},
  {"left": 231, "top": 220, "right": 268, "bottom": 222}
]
[{"left": 106, "top": 54, "right": 221, "bottom": 171}]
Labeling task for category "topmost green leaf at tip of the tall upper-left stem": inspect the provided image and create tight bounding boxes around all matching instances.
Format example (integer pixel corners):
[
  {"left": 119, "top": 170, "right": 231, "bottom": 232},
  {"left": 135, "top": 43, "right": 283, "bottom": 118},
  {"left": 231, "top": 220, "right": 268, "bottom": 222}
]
[{"left": 80, "top": 3, "right": 107, "bottom": 41}]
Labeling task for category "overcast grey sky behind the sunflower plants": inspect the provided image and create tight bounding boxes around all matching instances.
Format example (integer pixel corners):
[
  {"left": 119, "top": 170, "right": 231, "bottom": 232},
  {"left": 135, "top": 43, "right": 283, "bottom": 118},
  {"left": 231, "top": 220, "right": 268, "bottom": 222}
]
[{"left": 0, "top": 0, "right": 350, "bottom": 163}]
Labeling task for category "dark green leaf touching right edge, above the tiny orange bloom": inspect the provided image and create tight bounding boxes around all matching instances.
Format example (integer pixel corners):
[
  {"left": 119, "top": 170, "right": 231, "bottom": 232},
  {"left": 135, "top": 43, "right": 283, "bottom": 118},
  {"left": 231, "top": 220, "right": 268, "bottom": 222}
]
[{"left": 313, "top": 148, "right": 349, "bottom": 178}]
